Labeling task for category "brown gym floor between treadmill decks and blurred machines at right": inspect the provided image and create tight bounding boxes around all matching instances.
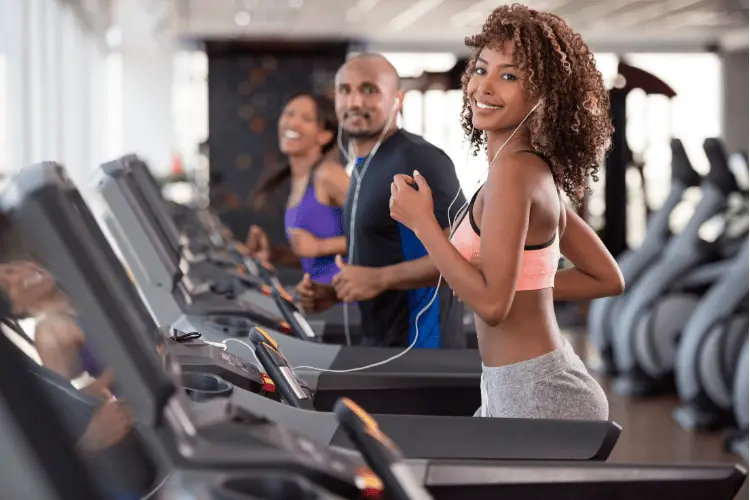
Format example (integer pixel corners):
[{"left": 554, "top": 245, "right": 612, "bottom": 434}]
[{"left": 565, "top": 331, "right": 749, "bottom": 500}]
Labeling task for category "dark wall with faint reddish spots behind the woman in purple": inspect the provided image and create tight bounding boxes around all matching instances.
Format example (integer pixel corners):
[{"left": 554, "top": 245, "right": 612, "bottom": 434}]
[{"left": 206, "top": 42, "right": 348, "bottom": 244}]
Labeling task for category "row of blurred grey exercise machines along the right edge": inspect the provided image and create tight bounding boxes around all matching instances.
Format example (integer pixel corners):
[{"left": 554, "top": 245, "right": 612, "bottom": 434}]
[{"left": 588, "top": 138, "right": 750, "bottom": 462}]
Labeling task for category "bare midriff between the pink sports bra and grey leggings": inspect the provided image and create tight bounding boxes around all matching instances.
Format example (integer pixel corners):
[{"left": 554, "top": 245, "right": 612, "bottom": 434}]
[{"left": 474, "top": 288, "right": 563, "bottom": 366}]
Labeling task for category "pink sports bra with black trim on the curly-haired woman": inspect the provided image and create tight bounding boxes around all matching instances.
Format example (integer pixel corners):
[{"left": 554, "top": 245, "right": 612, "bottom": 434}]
[{"left": 451, "top": 156, "right": 560, "bottom": 292}]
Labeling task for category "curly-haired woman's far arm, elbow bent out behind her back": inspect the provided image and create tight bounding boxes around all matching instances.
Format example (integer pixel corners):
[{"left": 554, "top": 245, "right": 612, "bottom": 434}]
[{"left": 554, "top": 207, "right": 625, "bottom": 301}]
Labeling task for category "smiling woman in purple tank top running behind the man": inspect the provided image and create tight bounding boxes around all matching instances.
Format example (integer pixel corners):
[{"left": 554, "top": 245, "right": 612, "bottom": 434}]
[{"left": 247, "top": 93, "right": 349, "bottom": 284}]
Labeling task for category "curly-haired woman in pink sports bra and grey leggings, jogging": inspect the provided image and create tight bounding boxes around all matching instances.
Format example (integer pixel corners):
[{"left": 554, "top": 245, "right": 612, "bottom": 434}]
[{"left": 391, "top": 5, "right": 624, "bottom": 420}]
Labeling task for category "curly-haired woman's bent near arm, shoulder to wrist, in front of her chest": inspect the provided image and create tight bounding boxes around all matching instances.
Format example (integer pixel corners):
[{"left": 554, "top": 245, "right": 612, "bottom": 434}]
[{"left": 412, "top": 156, "right": 536, "bottom": 326}]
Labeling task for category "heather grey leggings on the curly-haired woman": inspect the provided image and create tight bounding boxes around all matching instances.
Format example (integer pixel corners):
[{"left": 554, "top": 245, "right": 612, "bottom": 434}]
[{"left": 474, "top": 340, "right": 609, "bottom": 420}]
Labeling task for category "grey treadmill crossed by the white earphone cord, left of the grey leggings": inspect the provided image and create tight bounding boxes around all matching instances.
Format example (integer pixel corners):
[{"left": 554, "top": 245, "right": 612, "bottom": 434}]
[{"left": 94, "top": 156, "right": 488, "bottom": 416}]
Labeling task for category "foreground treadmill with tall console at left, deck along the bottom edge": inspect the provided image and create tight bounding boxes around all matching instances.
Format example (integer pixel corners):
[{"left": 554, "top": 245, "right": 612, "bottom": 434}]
[{"left": 7, "top": 164, "right": 746, "bottom": 500}]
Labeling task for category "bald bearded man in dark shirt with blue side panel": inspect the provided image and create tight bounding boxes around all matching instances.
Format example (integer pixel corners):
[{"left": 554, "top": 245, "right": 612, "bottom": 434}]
[{"left": 297, "top": 54, "right": 465, "bottom": 348}]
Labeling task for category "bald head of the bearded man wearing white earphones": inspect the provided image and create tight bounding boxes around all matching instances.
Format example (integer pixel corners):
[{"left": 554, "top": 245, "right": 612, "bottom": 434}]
[{"left": 336, "top": 53, "right": 403, "bottom": 139}]
